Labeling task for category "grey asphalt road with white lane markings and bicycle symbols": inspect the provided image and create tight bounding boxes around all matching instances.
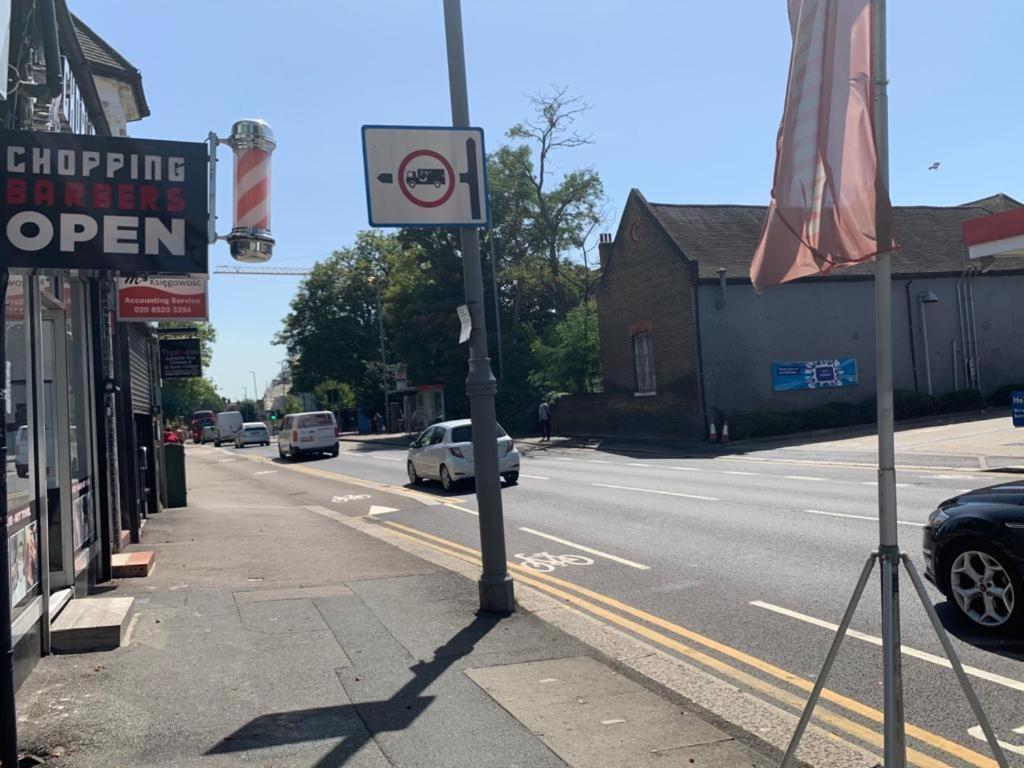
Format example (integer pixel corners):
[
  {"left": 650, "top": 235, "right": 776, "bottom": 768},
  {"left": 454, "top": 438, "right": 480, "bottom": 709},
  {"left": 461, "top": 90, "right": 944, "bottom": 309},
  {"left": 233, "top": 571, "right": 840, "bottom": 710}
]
[{"left": 221, "top": 442, "right": 1024, "bottom": 768}]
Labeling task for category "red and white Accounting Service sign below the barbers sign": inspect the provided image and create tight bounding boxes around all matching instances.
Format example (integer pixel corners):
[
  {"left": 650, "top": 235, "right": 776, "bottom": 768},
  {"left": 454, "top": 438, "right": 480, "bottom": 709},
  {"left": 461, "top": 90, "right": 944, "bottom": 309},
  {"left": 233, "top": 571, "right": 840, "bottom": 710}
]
[{"left": 118, "top": 274, "right": 209, "bottom": 323}]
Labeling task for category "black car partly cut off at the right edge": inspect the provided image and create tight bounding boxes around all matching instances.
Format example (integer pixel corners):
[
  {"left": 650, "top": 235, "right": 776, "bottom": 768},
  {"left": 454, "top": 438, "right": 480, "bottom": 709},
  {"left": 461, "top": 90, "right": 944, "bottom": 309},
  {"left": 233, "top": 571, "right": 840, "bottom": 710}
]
[{"left": 924, "top": 481, "right": 1024, "bottom": 631}]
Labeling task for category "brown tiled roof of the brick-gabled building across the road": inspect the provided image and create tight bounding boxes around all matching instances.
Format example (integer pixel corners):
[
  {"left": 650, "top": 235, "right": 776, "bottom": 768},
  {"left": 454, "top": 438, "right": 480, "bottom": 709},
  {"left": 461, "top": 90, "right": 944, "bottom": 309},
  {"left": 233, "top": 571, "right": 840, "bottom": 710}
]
[{"left": 634, "top": 190, "right": 1024, "bottom": 279}]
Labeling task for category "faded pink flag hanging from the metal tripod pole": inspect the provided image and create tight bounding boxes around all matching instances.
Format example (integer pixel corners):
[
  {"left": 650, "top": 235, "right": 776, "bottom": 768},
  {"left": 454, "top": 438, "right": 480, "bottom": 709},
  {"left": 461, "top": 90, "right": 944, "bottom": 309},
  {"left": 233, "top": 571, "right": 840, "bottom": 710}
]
[{"left": 751, "top": 0, "right": 894, "bottom": 293}]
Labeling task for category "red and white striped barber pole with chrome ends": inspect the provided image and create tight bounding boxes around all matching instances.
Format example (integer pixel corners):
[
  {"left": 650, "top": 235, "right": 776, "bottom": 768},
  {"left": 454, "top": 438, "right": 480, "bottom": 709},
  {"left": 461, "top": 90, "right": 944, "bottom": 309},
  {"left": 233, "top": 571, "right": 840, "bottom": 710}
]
[{"left": 224, "top": 120, "right": 276, "bottom": 262}]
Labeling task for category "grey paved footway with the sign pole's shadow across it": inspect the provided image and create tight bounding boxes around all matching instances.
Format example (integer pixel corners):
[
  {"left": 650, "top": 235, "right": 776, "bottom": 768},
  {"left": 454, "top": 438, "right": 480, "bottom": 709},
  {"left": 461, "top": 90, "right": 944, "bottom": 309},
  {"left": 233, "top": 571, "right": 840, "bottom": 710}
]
[{"left": 18, "top": 445, "right": 794, "bottom": 768}]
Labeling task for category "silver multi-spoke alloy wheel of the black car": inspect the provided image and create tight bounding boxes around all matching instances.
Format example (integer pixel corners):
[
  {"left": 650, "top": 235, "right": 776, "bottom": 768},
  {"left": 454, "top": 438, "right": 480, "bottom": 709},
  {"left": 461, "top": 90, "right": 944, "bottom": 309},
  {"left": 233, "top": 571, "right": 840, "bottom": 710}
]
[{"left": 945, "top": 541, "right": 1024, "bottom": 631}]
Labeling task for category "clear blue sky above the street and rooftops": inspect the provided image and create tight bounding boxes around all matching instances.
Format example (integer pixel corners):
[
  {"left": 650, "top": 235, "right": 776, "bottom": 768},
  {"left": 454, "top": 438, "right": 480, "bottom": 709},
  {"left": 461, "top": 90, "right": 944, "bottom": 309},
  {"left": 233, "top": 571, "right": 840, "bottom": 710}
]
[{"left": 70, "top": 0, "right": 1024, "bottom": 398}]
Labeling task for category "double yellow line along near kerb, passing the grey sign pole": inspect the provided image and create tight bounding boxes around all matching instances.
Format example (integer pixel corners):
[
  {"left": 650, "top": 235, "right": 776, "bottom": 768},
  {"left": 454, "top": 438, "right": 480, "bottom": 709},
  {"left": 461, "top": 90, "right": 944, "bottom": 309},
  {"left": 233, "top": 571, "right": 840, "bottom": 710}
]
[{"left": 383, "top": 520, "right": 998, "bottom": 768}]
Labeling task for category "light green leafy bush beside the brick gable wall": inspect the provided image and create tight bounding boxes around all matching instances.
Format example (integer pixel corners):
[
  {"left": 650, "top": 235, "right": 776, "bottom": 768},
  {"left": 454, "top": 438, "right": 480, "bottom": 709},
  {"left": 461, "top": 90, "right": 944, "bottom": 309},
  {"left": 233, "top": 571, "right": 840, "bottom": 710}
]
[{"left": 529, "top": 301, "right": 601, "bottom": 392}]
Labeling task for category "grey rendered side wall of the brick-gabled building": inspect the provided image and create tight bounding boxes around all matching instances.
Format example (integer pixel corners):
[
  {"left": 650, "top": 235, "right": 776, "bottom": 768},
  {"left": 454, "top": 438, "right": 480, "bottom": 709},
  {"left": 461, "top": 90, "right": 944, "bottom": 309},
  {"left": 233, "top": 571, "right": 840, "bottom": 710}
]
[{"left": 698, "top": 273, "right": 1024, "bottom": 414}]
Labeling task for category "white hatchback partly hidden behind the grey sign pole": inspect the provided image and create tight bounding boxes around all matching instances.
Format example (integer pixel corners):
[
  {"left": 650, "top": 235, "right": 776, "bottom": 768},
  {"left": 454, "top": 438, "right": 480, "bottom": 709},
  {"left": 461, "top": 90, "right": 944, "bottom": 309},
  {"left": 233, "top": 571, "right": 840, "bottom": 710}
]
[{"left": 406, "top": 419, "right": 519, "bottom": 490}]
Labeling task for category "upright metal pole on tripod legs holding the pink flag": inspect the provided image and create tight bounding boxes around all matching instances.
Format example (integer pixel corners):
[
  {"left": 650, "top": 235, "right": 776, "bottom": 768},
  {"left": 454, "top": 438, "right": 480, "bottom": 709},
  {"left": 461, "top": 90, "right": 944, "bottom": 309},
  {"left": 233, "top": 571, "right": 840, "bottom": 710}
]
[{"left": 871, "top": 0, "right": 906, "bottom": 768}]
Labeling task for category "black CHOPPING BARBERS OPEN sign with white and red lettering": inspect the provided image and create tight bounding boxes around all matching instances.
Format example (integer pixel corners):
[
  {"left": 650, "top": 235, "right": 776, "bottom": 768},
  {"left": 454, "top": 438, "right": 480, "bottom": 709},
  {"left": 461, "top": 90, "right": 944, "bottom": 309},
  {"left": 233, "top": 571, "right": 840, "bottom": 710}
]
[{"left": 0, "top": 131, "right": 209, "bottom": 273}]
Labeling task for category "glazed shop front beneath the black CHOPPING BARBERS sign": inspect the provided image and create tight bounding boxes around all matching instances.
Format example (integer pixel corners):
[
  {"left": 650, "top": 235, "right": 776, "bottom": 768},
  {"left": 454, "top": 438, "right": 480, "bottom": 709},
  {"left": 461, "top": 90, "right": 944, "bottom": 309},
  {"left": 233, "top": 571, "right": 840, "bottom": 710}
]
[{"left": 4, "top": 272, "right": 99, "bottom": 682}]
